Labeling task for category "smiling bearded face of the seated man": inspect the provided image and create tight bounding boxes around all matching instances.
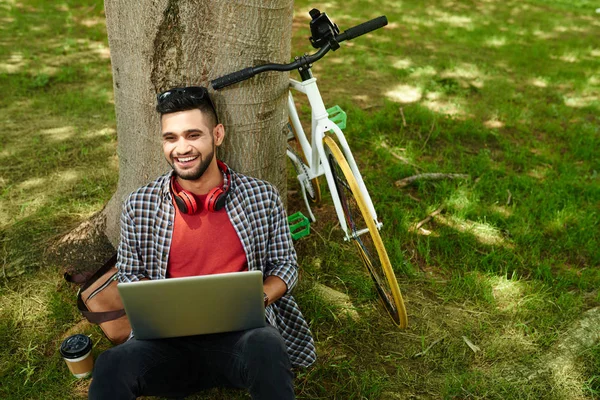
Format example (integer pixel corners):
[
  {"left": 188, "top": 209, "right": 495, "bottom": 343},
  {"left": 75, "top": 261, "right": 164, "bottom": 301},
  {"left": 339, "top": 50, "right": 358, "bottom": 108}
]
[{"left": 161, "top": 110, "right": 222, "bottom": 180}]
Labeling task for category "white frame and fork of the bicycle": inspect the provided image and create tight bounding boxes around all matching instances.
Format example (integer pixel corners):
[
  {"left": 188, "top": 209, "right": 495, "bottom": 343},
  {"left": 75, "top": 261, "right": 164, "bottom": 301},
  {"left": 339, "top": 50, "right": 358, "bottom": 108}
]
[{"left": 287, "top": 78, "right": 383, "bottom": 240}]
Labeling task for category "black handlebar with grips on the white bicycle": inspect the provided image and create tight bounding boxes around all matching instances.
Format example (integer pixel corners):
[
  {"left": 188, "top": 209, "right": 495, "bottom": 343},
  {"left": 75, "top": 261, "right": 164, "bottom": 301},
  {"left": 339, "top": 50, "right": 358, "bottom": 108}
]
[{"left": 210, "top": 15, "right": 388, "bottom": 90}]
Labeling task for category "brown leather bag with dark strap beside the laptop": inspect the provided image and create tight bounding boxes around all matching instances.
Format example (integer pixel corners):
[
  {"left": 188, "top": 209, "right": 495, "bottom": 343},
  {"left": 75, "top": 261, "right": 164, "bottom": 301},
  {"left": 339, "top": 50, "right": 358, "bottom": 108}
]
[{"left": 65, "top": 253, "right": 131, "bottom": 344}]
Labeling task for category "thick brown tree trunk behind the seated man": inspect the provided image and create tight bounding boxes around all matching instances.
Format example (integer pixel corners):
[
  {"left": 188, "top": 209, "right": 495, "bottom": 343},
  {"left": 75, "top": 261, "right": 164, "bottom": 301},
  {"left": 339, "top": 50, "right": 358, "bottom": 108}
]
[{"left": 54, "top": 0, "right": 293, "bottom": 269}]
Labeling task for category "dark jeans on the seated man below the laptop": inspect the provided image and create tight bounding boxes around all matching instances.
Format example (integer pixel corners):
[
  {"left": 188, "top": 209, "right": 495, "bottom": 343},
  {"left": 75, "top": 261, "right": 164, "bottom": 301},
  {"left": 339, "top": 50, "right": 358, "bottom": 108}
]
[{"left": 89, "top": 326, "right": 294, "bottom": 400}]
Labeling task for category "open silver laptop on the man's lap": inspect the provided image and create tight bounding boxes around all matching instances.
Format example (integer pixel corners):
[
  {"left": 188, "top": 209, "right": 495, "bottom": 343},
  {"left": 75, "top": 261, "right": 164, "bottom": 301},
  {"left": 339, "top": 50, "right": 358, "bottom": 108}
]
[{"left": 117, "top": 271, "right": 265, "bottom": 339}]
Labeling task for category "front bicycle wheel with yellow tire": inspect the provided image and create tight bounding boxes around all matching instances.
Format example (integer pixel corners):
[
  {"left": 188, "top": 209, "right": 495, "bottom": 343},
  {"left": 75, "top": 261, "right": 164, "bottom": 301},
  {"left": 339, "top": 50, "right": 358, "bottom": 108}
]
[{"left": 323, "top": 136, "right": 408, "bottom": 328}]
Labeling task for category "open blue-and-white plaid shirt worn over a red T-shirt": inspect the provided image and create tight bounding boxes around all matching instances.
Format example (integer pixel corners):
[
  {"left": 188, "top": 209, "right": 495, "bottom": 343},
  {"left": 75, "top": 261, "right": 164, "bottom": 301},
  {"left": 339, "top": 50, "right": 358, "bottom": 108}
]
[{"left": 117, "top": 164, "right": 316, "bottom": 366}]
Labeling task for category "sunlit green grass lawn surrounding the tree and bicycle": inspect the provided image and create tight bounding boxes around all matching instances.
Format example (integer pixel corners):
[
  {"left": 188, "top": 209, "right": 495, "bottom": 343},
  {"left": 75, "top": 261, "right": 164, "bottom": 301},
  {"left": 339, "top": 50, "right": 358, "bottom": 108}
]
[{"left": 0, "top": 0, "right": 600, "bottom": 399}]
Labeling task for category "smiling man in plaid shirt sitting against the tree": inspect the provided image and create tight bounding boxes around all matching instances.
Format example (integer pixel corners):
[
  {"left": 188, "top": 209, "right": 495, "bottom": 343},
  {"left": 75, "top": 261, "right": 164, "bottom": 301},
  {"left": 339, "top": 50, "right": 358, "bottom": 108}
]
[{"left": 89, "top": 87, "right": 316, "bottom": 400}]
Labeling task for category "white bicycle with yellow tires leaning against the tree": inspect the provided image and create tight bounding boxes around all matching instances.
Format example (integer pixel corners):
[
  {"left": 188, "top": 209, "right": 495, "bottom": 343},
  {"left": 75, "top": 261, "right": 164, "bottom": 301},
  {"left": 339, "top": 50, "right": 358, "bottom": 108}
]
[{"left": 211, "top": 9, "right": 408, "bottom": 328}]
